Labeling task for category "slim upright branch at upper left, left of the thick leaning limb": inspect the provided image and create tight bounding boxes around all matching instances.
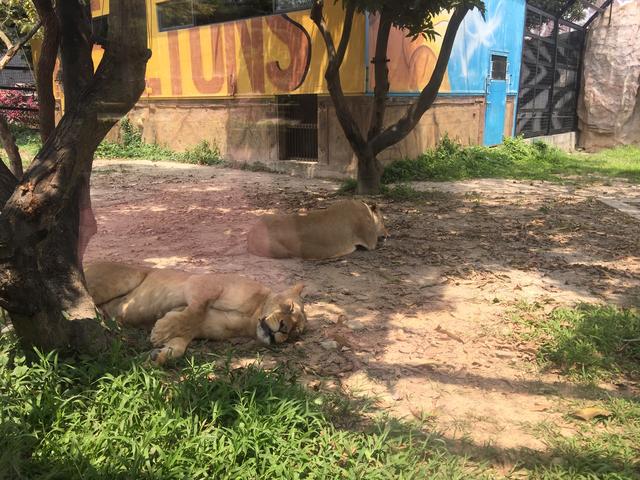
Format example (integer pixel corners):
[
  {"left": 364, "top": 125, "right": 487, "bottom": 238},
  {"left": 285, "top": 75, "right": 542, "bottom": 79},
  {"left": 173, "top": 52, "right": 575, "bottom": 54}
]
[{"left": 32, "top": 0, "right": 60, "bottom": 143}]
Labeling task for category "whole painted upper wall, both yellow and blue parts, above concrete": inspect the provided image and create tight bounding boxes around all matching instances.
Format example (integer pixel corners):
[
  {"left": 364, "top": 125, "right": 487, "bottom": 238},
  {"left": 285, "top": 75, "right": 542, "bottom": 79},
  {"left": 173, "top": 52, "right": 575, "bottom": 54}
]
[{"left": 85, "top": 0, "right": 524, "bottom": 98}]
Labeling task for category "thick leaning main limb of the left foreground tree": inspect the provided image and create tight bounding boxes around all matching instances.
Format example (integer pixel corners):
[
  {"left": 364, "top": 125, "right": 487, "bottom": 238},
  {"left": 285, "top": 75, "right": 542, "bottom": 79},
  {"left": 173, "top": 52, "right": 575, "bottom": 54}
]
[{"left": 9, "top": 0, "right": 150, "bottom": 225}]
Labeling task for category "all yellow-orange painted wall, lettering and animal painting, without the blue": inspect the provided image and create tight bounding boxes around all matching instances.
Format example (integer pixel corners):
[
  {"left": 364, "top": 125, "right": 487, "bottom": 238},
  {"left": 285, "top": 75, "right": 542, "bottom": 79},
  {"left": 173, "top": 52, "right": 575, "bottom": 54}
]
[{"left": 82, "top": 0, "right": 460, "bottom": 99}]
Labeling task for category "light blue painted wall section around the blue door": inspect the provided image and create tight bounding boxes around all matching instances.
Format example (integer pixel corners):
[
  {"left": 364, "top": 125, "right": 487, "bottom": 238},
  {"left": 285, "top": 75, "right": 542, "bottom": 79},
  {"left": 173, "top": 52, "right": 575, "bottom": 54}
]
[{"left": 449, "top": 0, "right": 525, "bottom": 95}]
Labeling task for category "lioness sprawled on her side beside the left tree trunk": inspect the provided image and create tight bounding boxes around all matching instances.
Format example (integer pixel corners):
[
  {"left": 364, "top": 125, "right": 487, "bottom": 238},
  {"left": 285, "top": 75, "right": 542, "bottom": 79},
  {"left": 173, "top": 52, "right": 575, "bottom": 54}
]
[{"left": 84, "top": 263, "right": 307, "bottom": 364}]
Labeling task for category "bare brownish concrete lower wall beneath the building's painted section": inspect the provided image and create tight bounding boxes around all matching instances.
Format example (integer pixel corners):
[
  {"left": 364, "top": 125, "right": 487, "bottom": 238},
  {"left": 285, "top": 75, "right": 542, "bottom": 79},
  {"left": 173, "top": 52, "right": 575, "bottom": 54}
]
[{"left": 121, "top": 96, "right": 484, "bottom": 178}]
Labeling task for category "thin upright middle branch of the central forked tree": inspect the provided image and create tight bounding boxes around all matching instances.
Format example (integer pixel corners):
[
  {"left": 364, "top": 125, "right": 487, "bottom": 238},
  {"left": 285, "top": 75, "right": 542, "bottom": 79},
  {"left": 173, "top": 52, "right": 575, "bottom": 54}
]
[{"left": 367, "top": 10, "right": 392, "bottom": 141}]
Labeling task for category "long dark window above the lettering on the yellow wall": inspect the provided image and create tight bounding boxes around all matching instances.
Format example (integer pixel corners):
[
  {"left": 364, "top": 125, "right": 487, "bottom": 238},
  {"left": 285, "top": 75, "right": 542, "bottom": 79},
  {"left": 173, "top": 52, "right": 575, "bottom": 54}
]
[{"left": 157, "top": 0, "right": 313, "bottom": 32}]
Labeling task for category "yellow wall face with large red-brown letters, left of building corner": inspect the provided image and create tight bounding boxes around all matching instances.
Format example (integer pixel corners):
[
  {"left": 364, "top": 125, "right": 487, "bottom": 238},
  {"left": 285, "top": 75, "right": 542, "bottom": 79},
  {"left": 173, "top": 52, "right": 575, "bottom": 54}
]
[{"left": 91, "top": 0, "right": 364, "bottom": 98}]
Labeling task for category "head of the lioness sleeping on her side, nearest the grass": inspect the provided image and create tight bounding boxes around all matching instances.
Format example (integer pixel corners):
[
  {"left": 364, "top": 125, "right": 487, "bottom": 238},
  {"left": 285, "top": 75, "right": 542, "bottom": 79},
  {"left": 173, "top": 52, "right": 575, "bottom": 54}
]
[{"left": 256, "top": 284, "right": 307, "bottom": 345}]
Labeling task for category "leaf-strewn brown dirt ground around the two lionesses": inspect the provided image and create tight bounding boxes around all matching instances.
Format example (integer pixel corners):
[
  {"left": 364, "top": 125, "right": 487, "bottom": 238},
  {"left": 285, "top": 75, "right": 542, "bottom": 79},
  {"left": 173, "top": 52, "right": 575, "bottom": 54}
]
[{"left": 87, "top": 161, "right": 640, "bottom": 462}]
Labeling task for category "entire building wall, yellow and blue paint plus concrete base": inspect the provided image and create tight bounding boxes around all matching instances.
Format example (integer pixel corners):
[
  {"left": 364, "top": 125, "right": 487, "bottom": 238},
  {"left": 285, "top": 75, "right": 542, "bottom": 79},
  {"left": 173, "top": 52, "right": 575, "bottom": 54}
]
[{"left": 85, "top": 0, "right": 525, "bottom": 176}]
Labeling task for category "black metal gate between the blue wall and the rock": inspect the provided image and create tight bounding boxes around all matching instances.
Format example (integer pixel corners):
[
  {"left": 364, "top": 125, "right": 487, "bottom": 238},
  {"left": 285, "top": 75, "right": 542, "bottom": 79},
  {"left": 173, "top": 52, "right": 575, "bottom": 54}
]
[{"left": 516, "top": 5, "right": 585, "bottom": 137}]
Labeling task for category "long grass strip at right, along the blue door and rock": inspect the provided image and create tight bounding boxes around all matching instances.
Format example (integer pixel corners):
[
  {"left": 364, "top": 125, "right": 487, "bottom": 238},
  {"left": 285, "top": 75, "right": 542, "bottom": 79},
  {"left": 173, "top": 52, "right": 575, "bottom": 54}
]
[{"left": 382, "top": 136, "right": 640, "bottom": 183}]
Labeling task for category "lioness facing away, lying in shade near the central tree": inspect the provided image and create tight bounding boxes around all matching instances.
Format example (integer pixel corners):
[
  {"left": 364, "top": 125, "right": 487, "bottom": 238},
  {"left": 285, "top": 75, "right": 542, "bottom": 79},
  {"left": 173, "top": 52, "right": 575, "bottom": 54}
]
[{"left": 247, "top": 200, "right": 389, "bottom": 259}]
